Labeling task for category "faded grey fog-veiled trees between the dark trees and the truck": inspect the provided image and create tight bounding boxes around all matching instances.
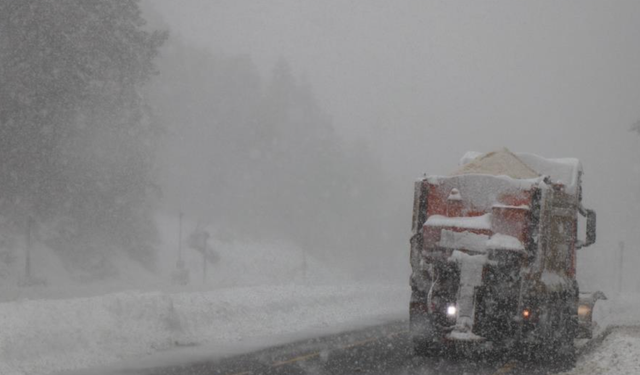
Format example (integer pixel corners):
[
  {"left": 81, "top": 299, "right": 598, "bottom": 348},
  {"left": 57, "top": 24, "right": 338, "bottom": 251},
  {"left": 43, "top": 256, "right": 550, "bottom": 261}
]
[{"left": 151, "top": 38, "right": 397, "bottom": 270}]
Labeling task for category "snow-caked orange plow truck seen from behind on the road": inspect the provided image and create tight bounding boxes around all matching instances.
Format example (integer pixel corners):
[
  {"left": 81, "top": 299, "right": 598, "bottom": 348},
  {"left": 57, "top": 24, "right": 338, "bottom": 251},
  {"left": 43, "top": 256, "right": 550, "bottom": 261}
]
[{"left": 409, "top": 149, "right": 605, "bottom": 363}]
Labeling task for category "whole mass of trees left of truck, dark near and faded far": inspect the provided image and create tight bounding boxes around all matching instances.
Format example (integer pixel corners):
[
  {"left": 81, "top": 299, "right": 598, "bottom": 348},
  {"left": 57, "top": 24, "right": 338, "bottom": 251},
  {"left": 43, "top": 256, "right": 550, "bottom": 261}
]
[{"left": 0, "top": 0, "right": 397, "bottom": 277}]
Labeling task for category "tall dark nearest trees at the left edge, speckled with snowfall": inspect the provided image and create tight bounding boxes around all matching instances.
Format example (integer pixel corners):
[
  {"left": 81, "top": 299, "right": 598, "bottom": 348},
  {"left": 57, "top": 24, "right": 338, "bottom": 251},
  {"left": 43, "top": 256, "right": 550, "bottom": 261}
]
[{"left": 0, "top": 0, "right": 167, "bottom": 280}]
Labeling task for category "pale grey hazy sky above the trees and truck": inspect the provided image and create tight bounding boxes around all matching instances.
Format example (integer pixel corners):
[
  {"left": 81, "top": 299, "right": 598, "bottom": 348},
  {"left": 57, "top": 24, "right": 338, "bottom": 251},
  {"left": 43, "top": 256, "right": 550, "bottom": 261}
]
[{"left": 151, "top": 0, "right": 640, "bottom": 290}]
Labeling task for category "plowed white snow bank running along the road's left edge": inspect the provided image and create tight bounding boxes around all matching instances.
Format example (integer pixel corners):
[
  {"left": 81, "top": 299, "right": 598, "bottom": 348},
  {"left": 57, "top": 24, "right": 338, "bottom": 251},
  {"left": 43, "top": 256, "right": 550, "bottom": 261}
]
[{"left": 0, "top": 285, "right": 410, "bottom": 375}]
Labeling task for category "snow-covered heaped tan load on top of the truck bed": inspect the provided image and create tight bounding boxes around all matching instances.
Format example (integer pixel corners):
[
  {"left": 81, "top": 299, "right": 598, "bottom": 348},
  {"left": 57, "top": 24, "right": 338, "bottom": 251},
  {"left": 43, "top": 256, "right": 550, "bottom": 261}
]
[{"left": 451, "top": 148, "right": 582, "bottom": 194}]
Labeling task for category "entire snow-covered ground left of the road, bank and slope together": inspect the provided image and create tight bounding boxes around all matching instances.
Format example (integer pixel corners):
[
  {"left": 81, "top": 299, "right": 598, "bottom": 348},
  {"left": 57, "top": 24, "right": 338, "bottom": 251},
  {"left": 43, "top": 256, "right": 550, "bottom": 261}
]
[{"left": 0, "top": 216, "right": 410, "bottom": 375}]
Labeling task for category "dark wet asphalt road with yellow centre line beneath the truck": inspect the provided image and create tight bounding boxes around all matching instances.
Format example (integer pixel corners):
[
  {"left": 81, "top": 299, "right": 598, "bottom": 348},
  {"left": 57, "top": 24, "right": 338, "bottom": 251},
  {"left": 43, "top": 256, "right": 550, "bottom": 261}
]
[{"left": 122, "top": 322, "right": 576, "bottom": 375}]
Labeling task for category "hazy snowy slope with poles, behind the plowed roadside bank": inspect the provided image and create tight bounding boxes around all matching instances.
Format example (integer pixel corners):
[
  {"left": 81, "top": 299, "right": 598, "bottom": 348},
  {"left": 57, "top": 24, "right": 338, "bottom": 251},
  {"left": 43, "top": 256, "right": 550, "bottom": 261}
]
[{"left": 0, "top": 215, "right": 356, "bottom": 302}]
